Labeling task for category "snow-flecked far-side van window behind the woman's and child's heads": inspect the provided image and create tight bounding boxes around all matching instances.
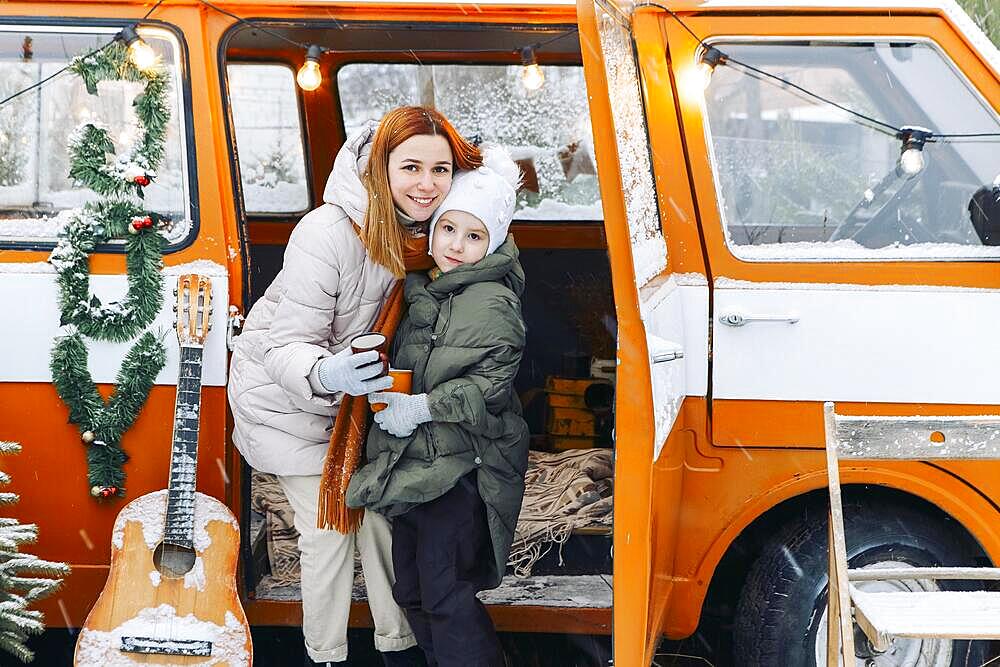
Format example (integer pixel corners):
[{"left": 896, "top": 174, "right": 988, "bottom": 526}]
[{"left": 337, "top": 63, "right": 603, "bottom": 221}]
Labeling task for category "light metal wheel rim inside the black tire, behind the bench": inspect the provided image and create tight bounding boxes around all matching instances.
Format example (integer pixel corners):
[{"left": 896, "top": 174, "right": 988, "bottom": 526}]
[{"left": 815, "top": 561, "right": 952, "bottom": 667}]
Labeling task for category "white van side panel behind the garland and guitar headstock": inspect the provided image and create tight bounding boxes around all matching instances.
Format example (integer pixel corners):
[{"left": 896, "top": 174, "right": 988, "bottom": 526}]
[{"left": 0, "top": 264, "right": 229, "bottom": 387}]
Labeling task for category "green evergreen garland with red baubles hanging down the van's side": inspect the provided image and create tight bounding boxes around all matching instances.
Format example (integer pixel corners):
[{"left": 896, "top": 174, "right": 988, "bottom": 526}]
[{"left": 49, "top": 40, "right": 170, "bottom": 498}]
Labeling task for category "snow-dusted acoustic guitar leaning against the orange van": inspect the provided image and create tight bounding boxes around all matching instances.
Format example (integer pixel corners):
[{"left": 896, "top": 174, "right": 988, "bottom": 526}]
[{"left": 74, "top": 274, "right": 253, "bottom": 667}]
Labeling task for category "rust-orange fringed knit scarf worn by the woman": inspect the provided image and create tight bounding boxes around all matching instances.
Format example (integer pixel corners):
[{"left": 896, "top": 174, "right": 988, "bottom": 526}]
[{"left": 316, "top": 236, "right": 434, "bottom": 534}]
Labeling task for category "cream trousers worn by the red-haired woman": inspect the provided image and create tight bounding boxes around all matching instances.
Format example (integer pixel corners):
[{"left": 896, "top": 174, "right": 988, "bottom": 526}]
[{"left": 278, "top": 475, "right": 417, "bottom": 662}]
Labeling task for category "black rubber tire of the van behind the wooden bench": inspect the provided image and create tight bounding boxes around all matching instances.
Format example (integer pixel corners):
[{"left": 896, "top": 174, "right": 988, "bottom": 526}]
[{"left": 734, "top": 497, "right": 990, "bottom": 667}]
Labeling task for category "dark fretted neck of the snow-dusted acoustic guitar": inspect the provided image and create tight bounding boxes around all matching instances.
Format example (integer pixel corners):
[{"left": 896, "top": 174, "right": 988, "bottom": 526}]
[{"left": 163, "top": 345, "right": 202, "bottom": 548}]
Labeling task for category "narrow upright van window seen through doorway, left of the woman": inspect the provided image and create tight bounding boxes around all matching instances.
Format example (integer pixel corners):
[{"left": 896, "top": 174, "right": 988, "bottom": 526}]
[{"left": 226, "top": 63, "right": 311, "bottom": 215}]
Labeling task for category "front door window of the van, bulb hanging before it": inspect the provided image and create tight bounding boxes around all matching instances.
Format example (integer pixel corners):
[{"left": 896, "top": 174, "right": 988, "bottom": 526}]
[{"left": 705, "top": 40, "right": 1000, "bottom": 260}]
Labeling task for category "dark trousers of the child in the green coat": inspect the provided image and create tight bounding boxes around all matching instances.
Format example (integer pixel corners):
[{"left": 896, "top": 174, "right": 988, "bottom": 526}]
[{"left": 392, "top": 473, "right": 504, "bottom": 667}]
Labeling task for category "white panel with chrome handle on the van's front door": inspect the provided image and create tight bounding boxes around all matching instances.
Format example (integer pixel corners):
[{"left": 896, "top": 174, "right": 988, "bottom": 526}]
[{"left": 713, "top": 278, "right": 1000, "bottom": 404}]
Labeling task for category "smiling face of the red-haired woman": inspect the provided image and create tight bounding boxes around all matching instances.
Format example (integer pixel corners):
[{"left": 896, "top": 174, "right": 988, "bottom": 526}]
[{"left": 389, "top": 134, "right": 452, "bottom": 222}]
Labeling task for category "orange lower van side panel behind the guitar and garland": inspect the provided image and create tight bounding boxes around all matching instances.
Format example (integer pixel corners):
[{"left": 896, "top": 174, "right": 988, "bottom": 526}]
[{"left": 0, "top": 383, "right": 230, "bottom": 612}]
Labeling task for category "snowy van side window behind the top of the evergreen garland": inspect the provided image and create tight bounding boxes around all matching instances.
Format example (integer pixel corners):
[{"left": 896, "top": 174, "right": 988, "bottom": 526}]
[{"left": 0, "top": 25, "right": 191, "bottom": 242}]
